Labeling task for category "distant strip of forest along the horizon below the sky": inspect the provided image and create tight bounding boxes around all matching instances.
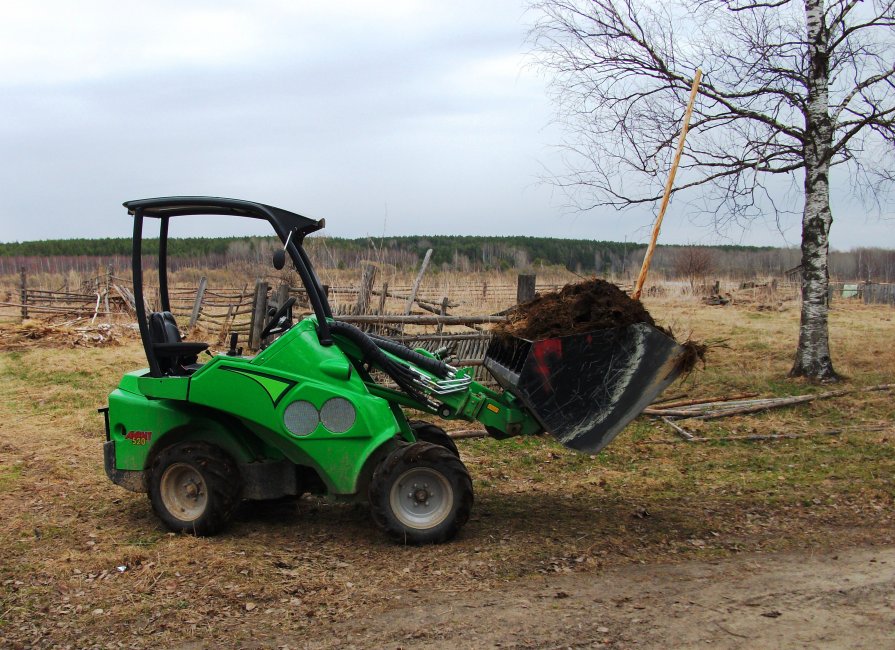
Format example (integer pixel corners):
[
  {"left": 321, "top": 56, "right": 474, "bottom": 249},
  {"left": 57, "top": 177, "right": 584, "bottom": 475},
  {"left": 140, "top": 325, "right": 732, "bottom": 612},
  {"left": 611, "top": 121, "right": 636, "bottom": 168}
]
[{"left": 0, "top": 235, "right": 895, "bottom": 282}]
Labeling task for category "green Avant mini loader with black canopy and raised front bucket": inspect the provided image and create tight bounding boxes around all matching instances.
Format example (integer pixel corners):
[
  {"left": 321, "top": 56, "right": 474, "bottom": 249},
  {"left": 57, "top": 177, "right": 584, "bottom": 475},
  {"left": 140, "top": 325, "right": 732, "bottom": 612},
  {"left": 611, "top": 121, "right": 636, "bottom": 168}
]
[{"left": 100, "top": 197, "right": 682, "bottom": 544}]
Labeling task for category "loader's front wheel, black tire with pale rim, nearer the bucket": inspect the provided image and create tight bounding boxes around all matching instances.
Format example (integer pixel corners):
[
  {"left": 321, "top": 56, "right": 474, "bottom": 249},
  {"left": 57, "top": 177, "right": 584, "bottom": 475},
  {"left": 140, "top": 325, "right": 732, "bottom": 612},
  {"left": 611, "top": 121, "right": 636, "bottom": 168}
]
[{"left": 369, "top": 442, "right": 473, "bottom": 544}]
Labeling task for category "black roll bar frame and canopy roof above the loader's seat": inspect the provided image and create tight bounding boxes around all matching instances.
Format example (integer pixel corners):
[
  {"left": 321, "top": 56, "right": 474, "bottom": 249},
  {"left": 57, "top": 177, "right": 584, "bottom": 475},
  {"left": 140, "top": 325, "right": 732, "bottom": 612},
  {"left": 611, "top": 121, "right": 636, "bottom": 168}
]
[{"left": 124, "top": 196, "right": 332, "bottom": 377}]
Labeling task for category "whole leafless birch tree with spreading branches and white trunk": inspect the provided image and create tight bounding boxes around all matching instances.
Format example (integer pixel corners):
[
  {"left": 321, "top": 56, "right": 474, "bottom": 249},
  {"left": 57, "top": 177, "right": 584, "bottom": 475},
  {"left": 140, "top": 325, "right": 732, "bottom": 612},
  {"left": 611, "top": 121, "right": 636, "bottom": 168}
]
[{"left": 532, "top": 0, "right": 895, "bottom": 381}]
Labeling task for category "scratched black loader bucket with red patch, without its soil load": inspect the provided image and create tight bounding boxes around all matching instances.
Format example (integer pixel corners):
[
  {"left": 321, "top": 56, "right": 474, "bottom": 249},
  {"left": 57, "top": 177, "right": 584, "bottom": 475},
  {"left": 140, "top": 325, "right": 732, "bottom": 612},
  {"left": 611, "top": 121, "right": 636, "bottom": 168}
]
[{"left": 485, "top": 323, "right": 684, "bottom": 453}]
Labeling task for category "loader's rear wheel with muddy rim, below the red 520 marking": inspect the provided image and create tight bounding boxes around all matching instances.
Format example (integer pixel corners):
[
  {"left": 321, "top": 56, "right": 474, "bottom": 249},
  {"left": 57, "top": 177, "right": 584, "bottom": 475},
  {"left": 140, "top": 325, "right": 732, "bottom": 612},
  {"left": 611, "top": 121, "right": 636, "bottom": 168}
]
[{"left": 149, "top": 442, "right": 242, "bottom": 536}]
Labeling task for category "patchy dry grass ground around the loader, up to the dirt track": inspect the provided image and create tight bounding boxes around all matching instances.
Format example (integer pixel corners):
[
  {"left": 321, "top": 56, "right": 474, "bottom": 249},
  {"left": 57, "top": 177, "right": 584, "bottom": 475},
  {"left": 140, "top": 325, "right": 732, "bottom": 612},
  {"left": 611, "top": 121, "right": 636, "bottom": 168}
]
[{"left": 0, "top": 288, "right": 895, "bottom": 648}]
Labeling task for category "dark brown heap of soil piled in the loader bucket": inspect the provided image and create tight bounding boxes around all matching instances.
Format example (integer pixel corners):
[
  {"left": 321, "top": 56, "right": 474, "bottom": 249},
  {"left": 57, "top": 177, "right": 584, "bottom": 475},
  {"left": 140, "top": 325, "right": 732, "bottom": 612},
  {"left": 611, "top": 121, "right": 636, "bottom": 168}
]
[{"left": 494, "top": 278, "right": 708, "bottom": 372}]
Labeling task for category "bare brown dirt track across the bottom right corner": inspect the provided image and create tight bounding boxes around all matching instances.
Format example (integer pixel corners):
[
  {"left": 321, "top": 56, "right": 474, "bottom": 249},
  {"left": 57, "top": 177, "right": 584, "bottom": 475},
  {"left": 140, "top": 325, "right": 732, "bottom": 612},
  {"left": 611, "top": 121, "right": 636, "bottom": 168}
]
[{"left": 302, "top": 546, "right": 895, "bottom": 649}]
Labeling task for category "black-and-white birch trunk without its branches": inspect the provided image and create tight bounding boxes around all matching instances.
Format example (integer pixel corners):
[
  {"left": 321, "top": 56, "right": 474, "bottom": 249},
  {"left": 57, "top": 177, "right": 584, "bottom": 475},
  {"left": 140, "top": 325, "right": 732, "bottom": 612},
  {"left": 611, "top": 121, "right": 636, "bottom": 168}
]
[{"left": 789, "top": 0, "right": 838, "bottom": 381}]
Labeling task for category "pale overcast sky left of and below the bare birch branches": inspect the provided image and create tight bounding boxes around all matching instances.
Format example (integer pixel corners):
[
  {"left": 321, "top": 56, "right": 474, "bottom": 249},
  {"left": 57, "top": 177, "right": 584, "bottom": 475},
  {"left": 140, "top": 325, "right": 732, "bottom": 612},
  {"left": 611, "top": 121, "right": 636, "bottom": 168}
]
[{"left": 0, "top": 0, "right": 895, "bottom": 249}]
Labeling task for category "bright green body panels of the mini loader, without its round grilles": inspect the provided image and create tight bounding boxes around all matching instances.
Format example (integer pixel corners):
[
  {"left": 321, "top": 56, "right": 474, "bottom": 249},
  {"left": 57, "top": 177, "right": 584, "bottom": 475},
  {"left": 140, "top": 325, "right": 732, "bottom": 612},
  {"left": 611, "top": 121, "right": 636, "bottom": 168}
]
[{"left": 109, "top": 319, "right": 413, "bottom": 495}]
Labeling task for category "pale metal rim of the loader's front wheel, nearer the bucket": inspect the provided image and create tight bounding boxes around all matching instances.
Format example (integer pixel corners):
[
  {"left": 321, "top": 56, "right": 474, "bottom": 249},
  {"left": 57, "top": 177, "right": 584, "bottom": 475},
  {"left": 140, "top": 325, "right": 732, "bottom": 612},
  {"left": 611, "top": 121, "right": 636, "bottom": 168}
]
[{"left": 389, "top": 467, "right": 454, "bottom": 530}]
